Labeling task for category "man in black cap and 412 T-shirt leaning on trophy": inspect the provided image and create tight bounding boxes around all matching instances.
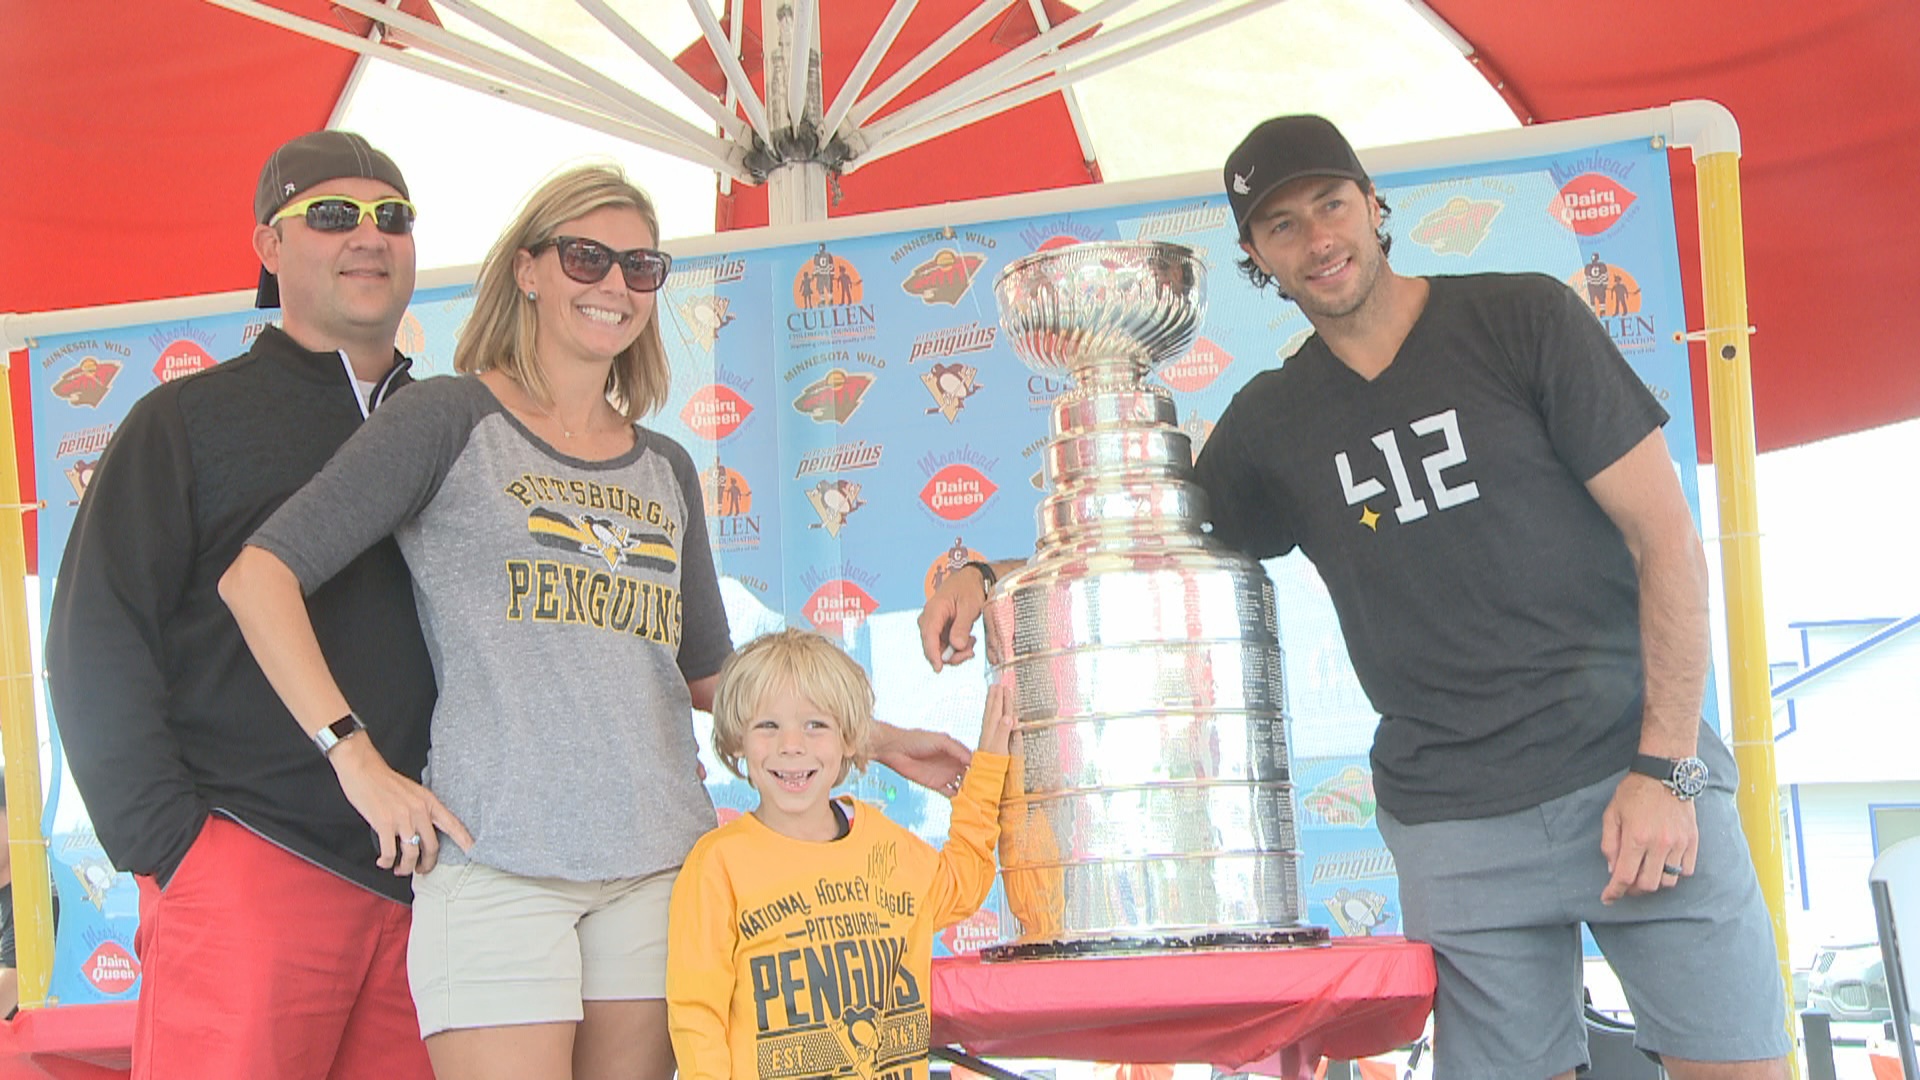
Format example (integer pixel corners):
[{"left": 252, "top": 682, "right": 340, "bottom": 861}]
[{"left": 922, "top": 115, "right": 1789, "bottom": 1080}]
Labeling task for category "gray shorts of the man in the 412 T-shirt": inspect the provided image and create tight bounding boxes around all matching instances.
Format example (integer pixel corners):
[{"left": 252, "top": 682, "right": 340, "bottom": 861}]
[{"left": 1379, "top": 748, "right": 1791, "bottom": 1080}]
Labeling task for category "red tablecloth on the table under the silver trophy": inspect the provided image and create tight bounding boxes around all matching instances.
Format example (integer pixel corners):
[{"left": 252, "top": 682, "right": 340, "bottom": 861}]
[{"left": 933, "top": 938, "right": 1434, "bottom": 1076}]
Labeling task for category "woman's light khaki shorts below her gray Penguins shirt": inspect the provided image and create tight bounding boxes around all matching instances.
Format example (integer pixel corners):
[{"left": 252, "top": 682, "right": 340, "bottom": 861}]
[{"left": 407, "top": 863, "right": 678, "bottom": 1038}]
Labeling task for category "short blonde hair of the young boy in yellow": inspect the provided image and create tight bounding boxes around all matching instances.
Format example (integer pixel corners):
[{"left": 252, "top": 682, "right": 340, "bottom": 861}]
[{"left": 714, "top": 628, "right": 874, "bottom": 784}]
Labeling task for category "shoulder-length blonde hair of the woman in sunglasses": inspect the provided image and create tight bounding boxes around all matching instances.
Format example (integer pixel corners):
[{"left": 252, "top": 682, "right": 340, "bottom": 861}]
[{"left": 453, "top": 165, "right": 672, "bottom": 421}]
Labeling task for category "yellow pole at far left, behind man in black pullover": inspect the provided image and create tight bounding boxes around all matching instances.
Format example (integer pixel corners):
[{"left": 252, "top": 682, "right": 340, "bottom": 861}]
[{"left": 0, "top": 357, "right": 54, "bottom": 1009}]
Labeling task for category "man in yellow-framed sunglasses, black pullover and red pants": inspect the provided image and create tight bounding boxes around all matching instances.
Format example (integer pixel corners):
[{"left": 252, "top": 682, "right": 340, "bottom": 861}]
[{"left": 46, "top": 131, "right": 453, "bottom": 1080}]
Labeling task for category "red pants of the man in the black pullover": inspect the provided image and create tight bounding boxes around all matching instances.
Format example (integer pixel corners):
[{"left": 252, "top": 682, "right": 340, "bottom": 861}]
[{"left": 132, "top": 817, "right": 434, "bottom": 1080}]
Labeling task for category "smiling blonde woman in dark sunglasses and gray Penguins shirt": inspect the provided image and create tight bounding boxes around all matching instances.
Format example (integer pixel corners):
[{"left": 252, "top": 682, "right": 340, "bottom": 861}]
[{"left": 221, "top": 167, "right": 730, "bottom": 1080}]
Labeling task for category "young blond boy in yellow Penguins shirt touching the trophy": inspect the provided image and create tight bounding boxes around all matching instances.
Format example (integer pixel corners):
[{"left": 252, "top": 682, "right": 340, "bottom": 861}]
[{"left": 666, "top": 630, "right": 1014, "bottom": 1080}]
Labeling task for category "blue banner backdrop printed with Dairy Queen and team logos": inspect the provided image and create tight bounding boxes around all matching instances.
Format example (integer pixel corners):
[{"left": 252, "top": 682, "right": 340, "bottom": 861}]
[{"left": 29, "top": 140, "right": 1689, "bottom": 1003}]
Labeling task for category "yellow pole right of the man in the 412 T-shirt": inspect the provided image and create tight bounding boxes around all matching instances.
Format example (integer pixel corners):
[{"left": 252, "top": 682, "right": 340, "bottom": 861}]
[{"left": 1693, "top": 152, "right": 1799, "bottom": 1074}]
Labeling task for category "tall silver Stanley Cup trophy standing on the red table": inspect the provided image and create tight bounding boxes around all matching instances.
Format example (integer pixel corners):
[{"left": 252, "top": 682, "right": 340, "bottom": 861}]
[{"left": 985, "top": 242, "right": 1327, "bottom": 959}]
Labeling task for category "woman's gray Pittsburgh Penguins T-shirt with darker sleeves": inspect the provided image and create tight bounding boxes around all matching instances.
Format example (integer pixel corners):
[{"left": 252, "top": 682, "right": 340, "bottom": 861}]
[{"left": 252, "top": 377, "right": 732, "bottom": 880}]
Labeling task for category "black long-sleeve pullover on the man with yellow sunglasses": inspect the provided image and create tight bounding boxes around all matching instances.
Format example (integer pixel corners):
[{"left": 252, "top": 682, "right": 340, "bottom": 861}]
[{"left": 46, "top": 327, "right": 434, "bottom": 901}]
